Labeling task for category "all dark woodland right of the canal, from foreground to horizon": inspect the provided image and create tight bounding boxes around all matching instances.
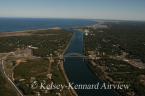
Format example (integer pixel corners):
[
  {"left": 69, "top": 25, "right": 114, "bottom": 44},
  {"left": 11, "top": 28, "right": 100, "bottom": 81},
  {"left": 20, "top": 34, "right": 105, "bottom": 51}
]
[{"left": 84, "top": 21, "right": 145, "bottom": 96}]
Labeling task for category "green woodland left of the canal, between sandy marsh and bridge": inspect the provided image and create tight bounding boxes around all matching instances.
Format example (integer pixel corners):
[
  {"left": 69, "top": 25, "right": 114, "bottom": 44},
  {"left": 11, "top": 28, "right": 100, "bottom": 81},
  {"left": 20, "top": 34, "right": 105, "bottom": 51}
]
[{"left": 0, "top": 30, "right": 72, "bottom": 57}]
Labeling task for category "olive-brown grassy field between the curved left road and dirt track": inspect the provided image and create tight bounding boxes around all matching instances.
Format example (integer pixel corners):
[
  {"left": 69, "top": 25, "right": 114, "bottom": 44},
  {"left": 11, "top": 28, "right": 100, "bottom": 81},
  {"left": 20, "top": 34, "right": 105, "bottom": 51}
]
[{"left": 14, "top": 59, "right": 49, "bottom": 80}]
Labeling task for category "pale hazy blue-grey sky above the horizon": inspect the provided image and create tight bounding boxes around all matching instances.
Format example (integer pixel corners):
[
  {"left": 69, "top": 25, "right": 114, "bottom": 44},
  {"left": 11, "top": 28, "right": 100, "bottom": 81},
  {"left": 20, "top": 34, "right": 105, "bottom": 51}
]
[{"left": 0, "top": 0, "right": 145, "bottom": 20}]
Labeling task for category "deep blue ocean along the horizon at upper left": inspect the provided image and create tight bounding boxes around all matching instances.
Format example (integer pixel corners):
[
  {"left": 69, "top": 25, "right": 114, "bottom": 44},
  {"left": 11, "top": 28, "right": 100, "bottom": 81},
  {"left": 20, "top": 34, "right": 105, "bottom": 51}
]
[{"left": 0, "top": 18, "right": 96, "bottom": 32}]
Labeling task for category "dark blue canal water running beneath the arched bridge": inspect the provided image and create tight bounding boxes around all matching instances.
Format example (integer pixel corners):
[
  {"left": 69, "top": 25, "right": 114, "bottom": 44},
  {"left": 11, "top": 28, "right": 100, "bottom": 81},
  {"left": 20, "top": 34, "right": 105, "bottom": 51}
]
[{"left": 64, "top": 31, "right": 118, "bottom": 96}]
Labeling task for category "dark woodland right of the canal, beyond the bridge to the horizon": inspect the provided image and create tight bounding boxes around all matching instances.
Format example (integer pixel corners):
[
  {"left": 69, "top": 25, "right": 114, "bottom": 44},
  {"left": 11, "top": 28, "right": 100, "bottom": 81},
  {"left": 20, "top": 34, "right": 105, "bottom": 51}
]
[{"left": 85, "top": 22, "right": 145, "bottom": 62}]
